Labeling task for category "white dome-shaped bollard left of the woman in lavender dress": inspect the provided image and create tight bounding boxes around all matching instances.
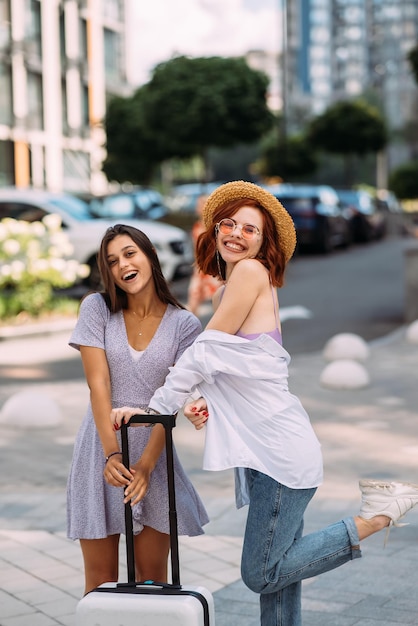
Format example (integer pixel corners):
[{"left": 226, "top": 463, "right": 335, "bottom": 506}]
[{"left": 0, "top": 389, "right": 62, "bottom": 429}]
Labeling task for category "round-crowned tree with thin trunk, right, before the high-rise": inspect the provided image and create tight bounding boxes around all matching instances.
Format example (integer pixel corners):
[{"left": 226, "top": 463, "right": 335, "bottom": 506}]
[{"left": 308, "top": 101, "right": 388, "bottom": 186}]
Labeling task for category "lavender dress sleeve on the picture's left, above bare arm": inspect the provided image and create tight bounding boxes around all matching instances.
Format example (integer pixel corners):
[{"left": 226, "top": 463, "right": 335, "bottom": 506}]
[{"left": 68, "top": 293, "right": 110, "bottom": 350}]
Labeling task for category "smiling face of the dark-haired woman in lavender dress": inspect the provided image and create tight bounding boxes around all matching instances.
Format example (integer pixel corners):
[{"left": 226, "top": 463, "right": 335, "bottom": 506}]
[{"left": 107, "top": 235, "right": 153, "bottom": 294}]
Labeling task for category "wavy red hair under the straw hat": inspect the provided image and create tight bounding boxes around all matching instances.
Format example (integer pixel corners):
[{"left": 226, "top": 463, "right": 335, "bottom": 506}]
[{"left": 196, "top": 198, "right": 286, "bottom": 287}]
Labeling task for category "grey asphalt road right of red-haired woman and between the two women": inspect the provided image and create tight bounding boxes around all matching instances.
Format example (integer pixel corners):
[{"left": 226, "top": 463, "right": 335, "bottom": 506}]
[{"left": 175, "top": 236, "right": 408, "bottom": 355}]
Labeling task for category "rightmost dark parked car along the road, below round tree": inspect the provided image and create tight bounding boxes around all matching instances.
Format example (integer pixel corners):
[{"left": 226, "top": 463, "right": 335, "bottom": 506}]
[{"left": 336, "top": 189, "right": 387, "bottom": 243}]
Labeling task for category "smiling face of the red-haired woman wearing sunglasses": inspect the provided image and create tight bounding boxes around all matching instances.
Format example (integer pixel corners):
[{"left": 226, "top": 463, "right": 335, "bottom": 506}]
[{"left": 217, "top": 206, "right": 263, "bottom": 269}]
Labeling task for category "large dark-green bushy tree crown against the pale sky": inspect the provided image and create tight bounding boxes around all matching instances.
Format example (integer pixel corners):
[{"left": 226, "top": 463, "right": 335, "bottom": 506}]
[{"left": 104, "top": 56, "right": 274, "bottom": 182}]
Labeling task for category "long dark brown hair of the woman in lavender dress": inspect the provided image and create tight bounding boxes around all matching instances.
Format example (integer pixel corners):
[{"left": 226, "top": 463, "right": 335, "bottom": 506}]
[{"left": 97, "top": 224, "right": 185, "bottom": 313}]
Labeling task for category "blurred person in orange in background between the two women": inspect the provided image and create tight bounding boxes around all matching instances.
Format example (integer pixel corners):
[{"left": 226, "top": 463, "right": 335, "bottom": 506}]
[{"left": 187, "top": 194, "right": 220, "bottom": 315}]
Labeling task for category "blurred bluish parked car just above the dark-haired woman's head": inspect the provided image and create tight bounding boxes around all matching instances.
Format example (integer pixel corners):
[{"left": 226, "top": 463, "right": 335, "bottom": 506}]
[{"left": 89, "top": 188, "right": 169, "bottom": 220}]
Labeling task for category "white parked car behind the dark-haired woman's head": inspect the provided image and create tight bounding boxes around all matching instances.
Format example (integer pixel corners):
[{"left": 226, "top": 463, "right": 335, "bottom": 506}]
[{"left": 0, "top": 187, "right": 194, "bottom": 288}]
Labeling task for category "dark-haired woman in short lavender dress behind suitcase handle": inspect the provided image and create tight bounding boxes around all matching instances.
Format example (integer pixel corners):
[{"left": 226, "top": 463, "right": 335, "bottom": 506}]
[{"left": 67, "top": 224, "right": 208, "bottom": 593}]
